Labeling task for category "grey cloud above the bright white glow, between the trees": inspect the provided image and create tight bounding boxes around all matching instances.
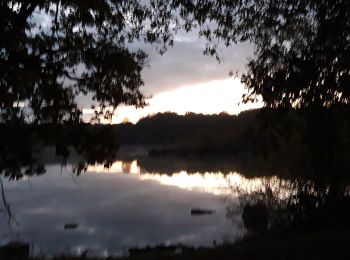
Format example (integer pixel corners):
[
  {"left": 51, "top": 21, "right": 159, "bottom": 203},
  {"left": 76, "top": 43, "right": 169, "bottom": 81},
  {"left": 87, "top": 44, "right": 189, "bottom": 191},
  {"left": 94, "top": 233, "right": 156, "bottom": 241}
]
[{"left": 143, "top": 38, "right": 253, "bottom": 94}]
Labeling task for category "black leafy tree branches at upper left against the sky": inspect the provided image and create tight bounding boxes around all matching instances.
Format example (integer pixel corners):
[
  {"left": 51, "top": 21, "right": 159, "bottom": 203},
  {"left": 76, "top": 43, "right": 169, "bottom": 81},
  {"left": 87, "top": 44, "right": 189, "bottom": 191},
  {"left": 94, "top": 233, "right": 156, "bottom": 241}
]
[{"left": 0, "top": 0, "right": 178, "bottom": 124}]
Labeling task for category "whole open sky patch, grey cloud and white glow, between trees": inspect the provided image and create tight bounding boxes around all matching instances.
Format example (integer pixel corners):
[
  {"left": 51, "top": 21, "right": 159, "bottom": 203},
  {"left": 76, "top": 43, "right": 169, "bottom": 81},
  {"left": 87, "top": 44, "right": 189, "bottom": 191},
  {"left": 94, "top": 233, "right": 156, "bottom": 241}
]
[{"left": 82, "top": 32, "right": 262, "bottom": 123}]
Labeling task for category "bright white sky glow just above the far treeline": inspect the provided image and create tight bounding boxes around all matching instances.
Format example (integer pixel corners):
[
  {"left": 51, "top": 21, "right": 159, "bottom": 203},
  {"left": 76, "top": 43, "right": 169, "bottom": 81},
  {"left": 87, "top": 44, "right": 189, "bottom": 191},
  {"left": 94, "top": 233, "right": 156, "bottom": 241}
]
[{"left": 84, "top": 78, "right": 262, "bottom": 124}]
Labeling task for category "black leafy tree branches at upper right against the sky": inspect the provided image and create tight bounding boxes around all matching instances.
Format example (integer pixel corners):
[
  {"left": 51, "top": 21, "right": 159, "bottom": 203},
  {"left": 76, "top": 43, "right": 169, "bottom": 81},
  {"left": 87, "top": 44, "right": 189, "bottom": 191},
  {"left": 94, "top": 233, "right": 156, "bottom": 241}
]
[{"left": 154, "top": 0, "right": 350, "bottom": 107}]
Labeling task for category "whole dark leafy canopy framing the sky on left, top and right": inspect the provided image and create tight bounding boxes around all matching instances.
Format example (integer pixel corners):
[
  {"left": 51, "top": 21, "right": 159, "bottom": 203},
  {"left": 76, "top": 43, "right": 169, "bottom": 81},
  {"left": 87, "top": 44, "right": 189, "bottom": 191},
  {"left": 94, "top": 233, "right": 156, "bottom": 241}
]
[{"left": 0, "top": 0, "right": 350, "bottom": 126}]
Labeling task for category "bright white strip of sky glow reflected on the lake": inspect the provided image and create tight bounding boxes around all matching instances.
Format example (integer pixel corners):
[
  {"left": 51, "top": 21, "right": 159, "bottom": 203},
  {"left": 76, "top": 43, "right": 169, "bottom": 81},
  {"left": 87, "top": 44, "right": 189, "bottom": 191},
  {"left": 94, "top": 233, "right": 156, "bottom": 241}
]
[{"left": 87, "top": 160, "right": 293, "bottom": 198}]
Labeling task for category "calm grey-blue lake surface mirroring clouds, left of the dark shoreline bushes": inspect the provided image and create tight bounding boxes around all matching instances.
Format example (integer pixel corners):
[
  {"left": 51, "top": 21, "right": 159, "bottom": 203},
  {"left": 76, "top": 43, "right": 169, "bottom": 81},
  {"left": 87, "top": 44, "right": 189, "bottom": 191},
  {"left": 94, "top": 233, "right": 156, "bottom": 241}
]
[{"left": 0, "top": 161, "right": 245, "bottom": 255}]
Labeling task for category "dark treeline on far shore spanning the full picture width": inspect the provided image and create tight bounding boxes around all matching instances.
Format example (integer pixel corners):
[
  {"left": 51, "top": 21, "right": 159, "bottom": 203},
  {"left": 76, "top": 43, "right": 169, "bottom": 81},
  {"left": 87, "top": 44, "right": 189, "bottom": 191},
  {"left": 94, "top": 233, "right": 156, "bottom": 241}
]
[{"left": 0, "top": 106, "right": 350, "bottom": 180}]
